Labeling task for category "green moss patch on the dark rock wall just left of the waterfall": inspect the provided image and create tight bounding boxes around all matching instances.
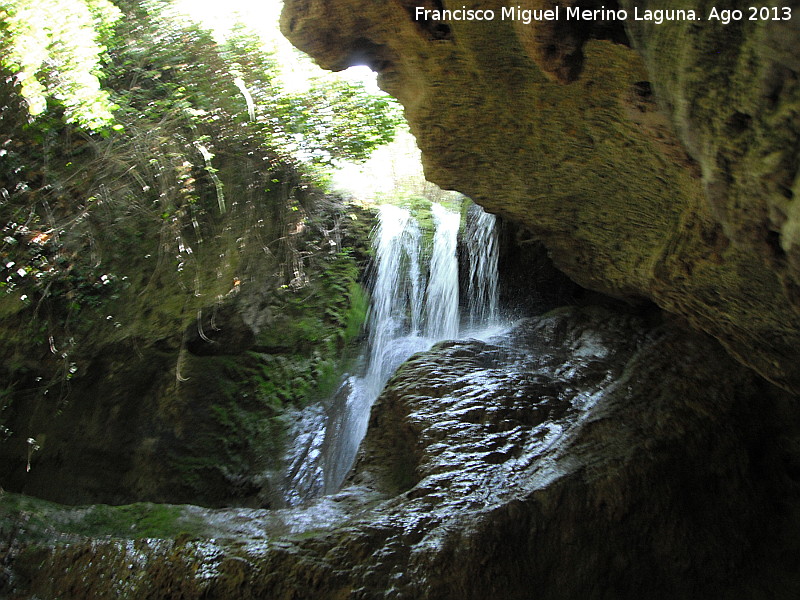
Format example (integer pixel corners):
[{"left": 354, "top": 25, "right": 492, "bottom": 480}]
[{"left": 167, "top": 244, "right": 376, "bottom": 501}]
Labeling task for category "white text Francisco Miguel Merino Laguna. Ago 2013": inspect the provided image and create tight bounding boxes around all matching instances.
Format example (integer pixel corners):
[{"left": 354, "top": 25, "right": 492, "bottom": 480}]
[{"left": 414, "top": 5, "right": 792, "bottom": 25}]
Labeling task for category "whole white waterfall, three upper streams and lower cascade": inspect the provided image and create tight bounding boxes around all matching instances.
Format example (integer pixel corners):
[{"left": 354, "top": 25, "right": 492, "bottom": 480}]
[{"left": 284, "top": 199, "right": 498, "bottom": 505}]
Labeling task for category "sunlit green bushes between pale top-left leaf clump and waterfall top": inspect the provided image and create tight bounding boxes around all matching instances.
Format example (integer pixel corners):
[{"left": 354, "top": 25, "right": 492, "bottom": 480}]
[{"left": 106, "top": 2, "right": 402, "bottom": 166}]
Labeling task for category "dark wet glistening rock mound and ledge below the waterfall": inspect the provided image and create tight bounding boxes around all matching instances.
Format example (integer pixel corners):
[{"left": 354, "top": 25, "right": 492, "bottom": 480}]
[{"left": 6, "top": 308, "right": 800, "bottom": 600}]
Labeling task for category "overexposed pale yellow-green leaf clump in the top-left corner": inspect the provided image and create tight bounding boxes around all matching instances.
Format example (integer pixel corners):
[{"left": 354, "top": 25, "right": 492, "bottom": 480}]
[{"left": 0, "top": 0, "right": 121, "bottom": 130}]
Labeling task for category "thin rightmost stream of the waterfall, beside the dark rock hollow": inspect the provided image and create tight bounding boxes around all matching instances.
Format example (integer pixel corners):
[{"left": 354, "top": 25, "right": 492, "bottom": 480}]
[{"left": 464, "top": 204, "right": 500, "bottom": 328}]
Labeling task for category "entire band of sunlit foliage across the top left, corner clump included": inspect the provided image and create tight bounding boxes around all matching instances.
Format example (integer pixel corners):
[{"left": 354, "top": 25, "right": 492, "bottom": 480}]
[{"left": 0, "top": 0, "right": 401, "bottom": 155}]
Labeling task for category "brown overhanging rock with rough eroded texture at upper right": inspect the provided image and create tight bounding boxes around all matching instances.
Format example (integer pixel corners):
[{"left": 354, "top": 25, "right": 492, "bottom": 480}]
[{"left": 282, "top": 0, "right": 800, "bottom": 391}]
